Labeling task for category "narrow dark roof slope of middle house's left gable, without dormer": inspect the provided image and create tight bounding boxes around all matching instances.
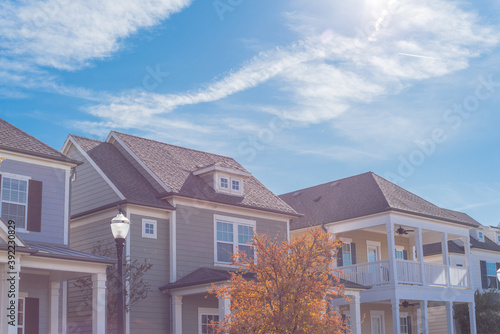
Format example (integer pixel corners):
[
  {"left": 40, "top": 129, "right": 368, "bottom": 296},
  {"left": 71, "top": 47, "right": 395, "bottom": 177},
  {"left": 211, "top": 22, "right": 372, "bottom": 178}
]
[{"left": 71, "top": 135, "right": 173, "bottom": 209}]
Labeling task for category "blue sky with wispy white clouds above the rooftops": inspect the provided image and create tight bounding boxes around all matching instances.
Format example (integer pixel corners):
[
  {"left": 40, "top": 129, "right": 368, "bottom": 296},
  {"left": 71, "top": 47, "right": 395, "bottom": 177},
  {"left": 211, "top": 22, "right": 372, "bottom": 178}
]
[{"left": 0, "top": 0, "right": 500, "bottom": 225}]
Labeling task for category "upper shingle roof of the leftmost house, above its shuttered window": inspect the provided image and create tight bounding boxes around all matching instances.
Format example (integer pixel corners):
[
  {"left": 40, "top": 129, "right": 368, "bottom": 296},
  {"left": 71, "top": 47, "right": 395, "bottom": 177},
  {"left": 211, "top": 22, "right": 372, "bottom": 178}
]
[{"left": 0, "top": 118, "right": 80, "bottom": 164}]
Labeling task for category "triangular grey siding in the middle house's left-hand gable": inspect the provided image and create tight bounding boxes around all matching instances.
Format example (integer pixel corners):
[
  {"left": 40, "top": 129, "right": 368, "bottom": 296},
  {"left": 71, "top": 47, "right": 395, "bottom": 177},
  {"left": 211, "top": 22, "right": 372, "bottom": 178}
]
[{"left": 68, "top": 146, "right": 120, "bottom": 215}]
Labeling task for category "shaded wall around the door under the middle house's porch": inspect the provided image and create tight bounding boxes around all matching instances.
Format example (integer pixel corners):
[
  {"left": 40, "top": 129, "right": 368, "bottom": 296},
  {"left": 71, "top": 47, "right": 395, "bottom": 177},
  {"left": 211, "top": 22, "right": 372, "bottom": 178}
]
[{"left": 182, "top": 294, "right": 219, "bottom": 334}]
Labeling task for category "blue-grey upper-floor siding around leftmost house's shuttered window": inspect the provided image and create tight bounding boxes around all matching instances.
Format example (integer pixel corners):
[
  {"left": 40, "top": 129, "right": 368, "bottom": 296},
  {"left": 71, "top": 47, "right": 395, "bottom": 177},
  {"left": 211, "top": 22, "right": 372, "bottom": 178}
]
[{"left": 0, "top": 160, "right": 65, "bottom": 244}]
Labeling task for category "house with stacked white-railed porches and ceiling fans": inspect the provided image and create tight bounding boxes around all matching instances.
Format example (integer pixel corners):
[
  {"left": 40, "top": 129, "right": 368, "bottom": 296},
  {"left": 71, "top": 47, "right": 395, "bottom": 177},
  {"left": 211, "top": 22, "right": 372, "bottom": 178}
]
[{"left": 280, "top": 172, "right": 479, "bottom": 334}]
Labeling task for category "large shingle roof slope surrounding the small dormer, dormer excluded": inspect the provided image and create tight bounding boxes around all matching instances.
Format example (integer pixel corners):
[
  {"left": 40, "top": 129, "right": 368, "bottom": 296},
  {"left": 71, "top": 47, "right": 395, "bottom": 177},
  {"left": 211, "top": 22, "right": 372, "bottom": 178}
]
[{"left": 110, "top": 131, "right": 299, "bottom": 216}]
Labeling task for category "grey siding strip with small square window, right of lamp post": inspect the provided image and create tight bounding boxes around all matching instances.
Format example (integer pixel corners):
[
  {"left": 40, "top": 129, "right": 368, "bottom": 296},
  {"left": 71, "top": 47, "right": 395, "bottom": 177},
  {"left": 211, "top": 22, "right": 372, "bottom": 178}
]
[{"left": 130, "top": 214, "right": 170, "bottom": 334}]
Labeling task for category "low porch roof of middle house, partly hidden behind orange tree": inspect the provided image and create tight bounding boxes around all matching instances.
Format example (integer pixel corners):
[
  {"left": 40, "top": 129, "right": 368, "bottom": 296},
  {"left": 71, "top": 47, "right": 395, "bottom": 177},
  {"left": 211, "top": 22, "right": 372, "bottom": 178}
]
[{"left": 160, "top": 267, "right": 369, "bottom": 291}]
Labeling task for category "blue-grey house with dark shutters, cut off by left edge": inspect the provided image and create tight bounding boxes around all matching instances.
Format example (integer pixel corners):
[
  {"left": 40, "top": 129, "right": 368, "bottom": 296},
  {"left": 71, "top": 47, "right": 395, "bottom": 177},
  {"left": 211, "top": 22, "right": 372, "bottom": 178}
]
[{"left": 0, "top": 119, "right": 114, "bottom": 334}]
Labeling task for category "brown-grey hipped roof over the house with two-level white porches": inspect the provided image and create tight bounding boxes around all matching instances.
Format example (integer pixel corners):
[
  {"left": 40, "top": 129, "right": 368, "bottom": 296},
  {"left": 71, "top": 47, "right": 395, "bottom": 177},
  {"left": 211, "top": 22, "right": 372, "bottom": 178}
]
[{"left": 280, "top": 172, "right": 479, "bottom": 229}]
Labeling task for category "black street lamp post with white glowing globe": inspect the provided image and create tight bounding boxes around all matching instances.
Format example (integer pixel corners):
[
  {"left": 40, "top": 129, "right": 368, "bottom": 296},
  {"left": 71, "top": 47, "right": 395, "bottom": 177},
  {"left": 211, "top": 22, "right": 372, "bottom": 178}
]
[{"left": 111, "top": 212, "right": 130, "bottom": 334}]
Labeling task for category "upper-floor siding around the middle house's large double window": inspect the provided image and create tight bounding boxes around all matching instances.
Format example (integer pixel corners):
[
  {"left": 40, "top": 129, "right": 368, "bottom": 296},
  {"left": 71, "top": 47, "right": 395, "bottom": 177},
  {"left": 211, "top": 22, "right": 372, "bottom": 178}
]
[{"left": 176, "top": 205, "right": 287, "bottom": 279}]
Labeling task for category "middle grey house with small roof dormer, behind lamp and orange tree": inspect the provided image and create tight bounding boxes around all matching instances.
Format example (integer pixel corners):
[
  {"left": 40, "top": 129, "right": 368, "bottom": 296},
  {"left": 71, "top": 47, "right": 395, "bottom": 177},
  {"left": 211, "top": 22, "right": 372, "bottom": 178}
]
[{"left": 62, "top": 131, "right": 298, "bottom": 334}]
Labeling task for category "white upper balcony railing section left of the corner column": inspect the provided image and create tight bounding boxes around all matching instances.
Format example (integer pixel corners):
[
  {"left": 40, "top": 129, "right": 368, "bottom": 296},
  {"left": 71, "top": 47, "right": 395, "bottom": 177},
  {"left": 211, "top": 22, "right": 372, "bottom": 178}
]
[{"left": 339, "top": 260, "right": 389, "bottom": 286}]
